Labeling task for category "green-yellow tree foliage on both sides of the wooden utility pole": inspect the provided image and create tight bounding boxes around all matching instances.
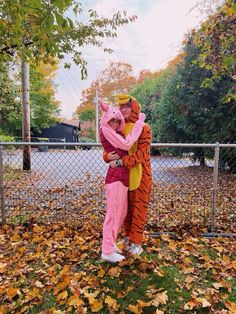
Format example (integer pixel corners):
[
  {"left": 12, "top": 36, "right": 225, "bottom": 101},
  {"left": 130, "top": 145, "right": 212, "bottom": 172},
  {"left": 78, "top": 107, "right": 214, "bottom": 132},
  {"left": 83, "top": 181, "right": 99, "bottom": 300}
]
[{"left": 0, "top": 60, "right": 58, "bottom": 137}]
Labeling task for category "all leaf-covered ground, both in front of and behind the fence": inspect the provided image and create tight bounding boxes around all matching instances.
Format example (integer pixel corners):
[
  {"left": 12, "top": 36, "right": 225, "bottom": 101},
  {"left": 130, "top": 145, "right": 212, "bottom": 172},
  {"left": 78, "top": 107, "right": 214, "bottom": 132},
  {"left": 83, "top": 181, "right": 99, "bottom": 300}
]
[{"left": 0, "top": 167, "right": 236, "bottom": 314}]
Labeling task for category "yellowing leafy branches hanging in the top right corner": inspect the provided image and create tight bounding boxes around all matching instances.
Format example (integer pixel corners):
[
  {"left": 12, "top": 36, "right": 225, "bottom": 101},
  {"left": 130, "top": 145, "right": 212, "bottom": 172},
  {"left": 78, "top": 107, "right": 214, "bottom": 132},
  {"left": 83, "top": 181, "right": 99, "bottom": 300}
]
[{"left": 194, "top": 0, "right": 236, "bottom": 87}]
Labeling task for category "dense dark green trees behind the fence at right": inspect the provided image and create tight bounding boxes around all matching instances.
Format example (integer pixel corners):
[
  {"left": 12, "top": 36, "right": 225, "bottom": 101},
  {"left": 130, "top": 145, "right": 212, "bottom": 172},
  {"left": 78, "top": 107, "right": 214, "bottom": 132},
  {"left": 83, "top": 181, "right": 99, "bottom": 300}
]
[{"left": 157, "top": 40, "right": 236, "bottom": 171}]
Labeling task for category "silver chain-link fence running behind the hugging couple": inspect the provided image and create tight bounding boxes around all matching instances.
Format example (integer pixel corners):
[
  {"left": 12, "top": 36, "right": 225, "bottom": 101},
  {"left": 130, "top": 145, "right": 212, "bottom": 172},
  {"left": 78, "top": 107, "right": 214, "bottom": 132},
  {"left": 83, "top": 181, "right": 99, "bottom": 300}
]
[{"left": 0, "top": 143, "right": 236, "bottom": 233}]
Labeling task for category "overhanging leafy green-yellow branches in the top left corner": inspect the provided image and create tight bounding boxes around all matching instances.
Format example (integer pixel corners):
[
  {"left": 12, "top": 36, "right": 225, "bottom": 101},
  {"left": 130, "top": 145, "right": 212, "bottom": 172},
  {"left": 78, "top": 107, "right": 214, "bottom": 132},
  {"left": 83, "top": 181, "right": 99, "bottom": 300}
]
[{"left": 0, "top": 0, "right": 136, "bottom": 78}]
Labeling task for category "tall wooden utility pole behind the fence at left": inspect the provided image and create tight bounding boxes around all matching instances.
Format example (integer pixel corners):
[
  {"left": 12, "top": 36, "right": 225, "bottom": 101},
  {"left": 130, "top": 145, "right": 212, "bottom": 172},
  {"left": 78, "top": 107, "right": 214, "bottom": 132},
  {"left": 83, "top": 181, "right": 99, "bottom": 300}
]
[{"left": 21, "top": 60, "right": 31, "bottom": 170}]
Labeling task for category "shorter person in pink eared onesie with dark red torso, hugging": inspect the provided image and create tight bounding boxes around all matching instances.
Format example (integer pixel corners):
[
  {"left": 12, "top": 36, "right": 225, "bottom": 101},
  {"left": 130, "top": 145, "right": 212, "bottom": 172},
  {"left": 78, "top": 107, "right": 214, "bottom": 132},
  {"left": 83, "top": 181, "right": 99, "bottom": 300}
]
[{"left": 99, "top": 103, "right": 145, "bottom": 263}]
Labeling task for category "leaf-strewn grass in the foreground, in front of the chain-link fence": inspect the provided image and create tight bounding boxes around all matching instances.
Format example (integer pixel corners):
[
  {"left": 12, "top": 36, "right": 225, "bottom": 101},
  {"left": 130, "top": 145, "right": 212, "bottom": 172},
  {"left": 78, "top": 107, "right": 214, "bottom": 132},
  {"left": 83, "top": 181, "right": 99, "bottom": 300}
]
[{"left": 0, "top": 218, "right": 236, "bottom": 314}]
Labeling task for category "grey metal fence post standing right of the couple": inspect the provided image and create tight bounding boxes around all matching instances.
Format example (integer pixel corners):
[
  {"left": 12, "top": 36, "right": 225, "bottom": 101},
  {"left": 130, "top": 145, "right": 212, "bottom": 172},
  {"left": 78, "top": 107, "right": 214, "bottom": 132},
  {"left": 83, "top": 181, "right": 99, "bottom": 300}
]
[{"left": 211, "top": 142, "right": 220, "bottom": 232}]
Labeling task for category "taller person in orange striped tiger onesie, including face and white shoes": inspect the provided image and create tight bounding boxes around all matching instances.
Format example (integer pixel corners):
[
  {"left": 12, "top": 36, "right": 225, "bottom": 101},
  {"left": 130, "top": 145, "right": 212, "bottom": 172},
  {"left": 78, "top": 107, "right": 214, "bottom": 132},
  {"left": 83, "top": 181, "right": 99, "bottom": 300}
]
[{"left": 103, "top": 94, "right": 152, "bottom": 255}]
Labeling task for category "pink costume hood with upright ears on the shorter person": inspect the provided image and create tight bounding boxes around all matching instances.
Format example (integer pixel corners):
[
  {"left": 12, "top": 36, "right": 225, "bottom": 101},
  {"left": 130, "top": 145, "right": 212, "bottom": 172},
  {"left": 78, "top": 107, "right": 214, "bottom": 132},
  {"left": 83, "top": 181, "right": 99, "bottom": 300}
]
[{"left": 100, "top": 102, "right": 125, "bottom": 132}]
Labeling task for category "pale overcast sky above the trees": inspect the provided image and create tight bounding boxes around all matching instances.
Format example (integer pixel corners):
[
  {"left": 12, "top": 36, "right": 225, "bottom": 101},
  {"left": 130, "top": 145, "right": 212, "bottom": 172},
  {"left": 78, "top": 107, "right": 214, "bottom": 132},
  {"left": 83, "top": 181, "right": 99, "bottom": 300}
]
[{"left": 56, "top": 0, "right": 210, "bottom": 118}]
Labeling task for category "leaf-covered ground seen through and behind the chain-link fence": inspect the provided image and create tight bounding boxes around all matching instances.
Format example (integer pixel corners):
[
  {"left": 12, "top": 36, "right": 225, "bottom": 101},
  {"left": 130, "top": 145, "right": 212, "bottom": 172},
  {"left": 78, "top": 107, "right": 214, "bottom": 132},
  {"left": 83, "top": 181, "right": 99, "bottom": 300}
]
[{"left": 5, "top": 167, "right": 236, "bottom": 234}]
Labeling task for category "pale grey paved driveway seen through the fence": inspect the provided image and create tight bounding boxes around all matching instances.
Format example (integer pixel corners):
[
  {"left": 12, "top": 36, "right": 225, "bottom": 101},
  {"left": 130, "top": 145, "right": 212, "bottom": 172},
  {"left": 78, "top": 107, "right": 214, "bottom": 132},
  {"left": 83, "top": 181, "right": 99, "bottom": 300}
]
[{"left": 4, "top": 149, "right": 206, "bottom": 184}]
